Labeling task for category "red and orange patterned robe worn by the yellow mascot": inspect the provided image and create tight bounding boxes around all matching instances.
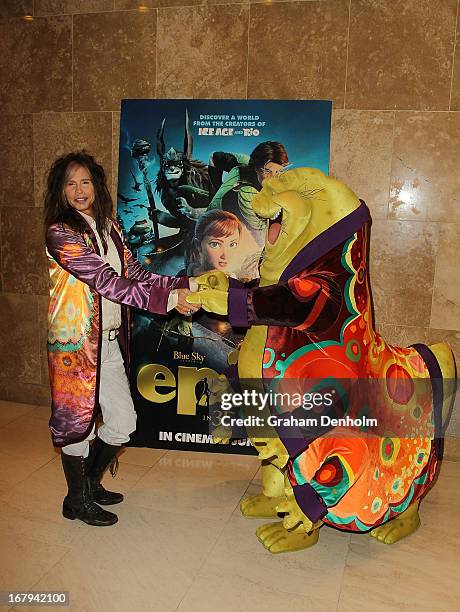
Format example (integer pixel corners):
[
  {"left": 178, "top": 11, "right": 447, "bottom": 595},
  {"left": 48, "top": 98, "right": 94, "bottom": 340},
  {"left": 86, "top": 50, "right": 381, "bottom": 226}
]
[{"left": 228, "top": 203, "right": 443, "bottom": 531}]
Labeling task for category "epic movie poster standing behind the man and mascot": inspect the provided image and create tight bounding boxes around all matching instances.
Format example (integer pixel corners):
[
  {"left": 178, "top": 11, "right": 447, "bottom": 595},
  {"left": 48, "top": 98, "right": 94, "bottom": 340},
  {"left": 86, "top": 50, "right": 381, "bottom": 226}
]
[{"left": 117, "top": 100, "right": 331, "bottom": 453}]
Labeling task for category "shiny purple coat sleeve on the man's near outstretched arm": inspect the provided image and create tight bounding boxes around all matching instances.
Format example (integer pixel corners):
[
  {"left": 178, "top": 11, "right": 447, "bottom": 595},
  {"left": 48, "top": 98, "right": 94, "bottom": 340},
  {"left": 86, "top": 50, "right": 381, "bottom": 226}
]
[{"left": 46, "top": 223, "right": 188, "bottom": 314}]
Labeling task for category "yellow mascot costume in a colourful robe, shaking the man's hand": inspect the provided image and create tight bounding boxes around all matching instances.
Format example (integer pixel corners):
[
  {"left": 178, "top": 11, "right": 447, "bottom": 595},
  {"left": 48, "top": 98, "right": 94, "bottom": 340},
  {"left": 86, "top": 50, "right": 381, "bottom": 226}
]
[{"left": 188, "top": 168, "right": 456, "bottom": 553}]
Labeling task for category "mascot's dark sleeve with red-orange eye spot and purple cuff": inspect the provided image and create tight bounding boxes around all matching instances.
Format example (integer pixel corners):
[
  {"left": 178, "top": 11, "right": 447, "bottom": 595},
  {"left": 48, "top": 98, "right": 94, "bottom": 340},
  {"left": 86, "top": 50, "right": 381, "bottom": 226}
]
[{"left": 228, "top": 275, "right": 342, "bottom": 329}]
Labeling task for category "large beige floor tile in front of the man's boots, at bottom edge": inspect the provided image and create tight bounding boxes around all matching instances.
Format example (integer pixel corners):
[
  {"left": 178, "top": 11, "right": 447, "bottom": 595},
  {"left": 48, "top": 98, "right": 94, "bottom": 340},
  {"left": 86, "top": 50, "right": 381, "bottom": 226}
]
[{"left": 20, "top": 501, "right": 226, "bottom": 612}]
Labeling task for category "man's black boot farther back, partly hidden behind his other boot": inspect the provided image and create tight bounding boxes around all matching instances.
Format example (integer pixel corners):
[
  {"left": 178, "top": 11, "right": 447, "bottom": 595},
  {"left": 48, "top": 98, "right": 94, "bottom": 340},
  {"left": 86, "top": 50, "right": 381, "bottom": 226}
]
[{"left": 87, "top": 437, "right": 123, "bottom": 506}]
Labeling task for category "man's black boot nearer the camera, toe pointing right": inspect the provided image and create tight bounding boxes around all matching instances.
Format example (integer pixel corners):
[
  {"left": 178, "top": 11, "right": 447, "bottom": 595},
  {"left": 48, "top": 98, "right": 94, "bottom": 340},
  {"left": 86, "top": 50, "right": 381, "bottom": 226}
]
[{"left": 61, "top": 452, "right": 118, "bottom": 527}]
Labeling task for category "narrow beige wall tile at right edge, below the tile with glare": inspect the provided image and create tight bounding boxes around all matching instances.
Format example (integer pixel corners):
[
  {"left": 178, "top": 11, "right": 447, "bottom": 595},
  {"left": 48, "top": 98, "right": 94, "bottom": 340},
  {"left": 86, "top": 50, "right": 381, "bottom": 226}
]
[{"left": 430, "top": 223, "right": 460, "bottom": 329}]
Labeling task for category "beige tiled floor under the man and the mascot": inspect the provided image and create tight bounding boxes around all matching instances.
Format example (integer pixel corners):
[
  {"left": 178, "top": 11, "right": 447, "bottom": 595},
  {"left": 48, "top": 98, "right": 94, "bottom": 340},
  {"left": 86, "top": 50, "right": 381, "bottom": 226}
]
[{"left": 0, "top": 402, "right": 460, "bottom": 612}]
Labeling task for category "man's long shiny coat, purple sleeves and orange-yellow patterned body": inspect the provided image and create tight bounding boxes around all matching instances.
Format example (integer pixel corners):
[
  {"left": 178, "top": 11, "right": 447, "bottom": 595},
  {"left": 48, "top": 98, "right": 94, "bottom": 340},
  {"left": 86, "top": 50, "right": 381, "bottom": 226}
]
[{"left": 46, "top": 223, "right": 188, "bottom": 446}]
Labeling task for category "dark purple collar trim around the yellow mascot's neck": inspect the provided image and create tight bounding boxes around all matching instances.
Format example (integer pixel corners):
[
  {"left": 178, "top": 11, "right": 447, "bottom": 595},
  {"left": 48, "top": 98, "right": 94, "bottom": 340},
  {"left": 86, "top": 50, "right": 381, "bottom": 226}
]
[{"left": 280, "top": 200, "right": 371, "bottom": 282}]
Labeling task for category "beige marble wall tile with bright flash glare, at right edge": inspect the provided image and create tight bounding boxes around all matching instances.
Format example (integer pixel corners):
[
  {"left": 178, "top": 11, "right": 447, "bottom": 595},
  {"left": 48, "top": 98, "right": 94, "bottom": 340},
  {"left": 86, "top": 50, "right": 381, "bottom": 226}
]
[{"left": 389, "top": 112, "right": 460, "bottom": 222}]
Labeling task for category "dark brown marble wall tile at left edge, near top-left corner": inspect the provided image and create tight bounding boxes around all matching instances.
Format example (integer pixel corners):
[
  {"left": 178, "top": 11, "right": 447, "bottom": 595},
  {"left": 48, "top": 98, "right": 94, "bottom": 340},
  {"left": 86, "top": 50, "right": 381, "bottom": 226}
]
[{"left": 0, "top": 17, "right": 72, "bottom": 114}]
